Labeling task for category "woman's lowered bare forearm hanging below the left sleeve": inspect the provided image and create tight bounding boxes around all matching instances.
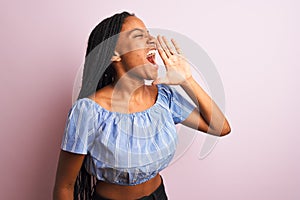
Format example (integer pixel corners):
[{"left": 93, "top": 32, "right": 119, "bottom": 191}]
[{"left": 53, "top": 150, "right": 85, "bottom": 200}]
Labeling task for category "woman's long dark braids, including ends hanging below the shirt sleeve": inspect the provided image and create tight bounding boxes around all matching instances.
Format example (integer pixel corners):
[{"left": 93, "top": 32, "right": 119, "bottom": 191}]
[{"left": 74, "top": 12, "right": 133, "bottom": 200}]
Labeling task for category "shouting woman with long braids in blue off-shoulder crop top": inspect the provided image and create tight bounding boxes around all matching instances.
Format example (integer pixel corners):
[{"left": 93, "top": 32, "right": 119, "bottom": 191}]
[{"left": 54, "top": 12, "right": 230, "bottom": 200}]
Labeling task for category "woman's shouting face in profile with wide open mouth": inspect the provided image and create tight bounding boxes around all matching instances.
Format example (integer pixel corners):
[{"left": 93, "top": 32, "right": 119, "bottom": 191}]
[{"left": 116, "top": 16, "right": 158, "bottom": 80}]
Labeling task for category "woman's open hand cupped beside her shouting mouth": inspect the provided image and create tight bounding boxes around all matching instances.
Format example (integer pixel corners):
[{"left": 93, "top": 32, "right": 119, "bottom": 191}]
[{"left": 153, "top": 36, "right": 192, "bottom": 85}]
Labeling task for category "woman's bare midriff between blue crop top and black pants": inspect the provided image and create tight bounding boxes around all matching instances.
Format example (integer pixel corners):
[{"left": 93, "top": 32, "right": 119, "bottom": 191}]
[{"left": 96, "top": 174, "right": 161, "bottom": 200}]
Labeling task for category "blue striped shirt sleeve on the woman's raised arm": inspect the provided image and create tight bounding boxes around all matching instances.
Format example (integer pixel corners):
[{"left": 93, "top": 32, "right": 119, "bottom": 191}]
[{"left": 170, "top": 87, "right": 196, "bottom": 124}]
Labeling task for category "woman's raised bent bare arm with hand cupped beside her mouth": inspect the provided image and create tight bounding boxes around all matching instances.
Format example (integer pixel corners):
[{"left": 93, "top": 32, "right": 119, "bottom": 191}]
[{"left": 154, "top": 36, "right": 231, "bottom": 136}]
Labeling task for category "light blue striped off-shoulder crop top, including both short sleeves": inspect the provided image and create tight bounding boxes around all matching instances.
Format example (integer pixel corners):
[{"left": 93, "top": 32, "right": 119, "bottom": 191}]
[{"left": 61, "top": 85, "right": 195, "bottom": 185}]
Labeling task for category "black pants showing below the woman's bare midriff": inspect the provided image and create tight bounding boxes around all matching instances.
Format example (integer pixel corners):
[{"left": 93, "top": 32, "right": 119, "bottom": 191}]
[{"left": 93, "top": 176, "right": 168, "bottom": 200}]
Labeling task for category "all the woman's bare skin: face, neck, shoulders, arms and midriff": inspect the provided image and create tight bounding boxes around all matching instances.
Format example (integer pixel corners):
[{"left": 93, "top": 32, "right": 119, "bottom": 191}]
[{"left": 53, "top": 16, "right": 230, "bottom": 200}]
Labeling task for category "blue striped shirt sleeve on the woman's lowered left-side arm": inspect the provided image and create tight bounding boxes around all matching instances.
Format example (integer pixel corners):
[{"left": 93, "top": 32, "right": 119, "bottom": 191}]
[{"left": 61, "top": 99, "right": 95, "bottom": 154}]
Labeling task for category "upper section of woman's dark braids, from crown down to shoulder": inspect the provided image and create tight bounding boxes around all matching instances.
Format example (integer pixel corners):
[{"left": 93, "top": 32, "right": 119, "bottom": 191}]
[{"left": 78, "top": 12, "right": 134, "bottom": 99}]
